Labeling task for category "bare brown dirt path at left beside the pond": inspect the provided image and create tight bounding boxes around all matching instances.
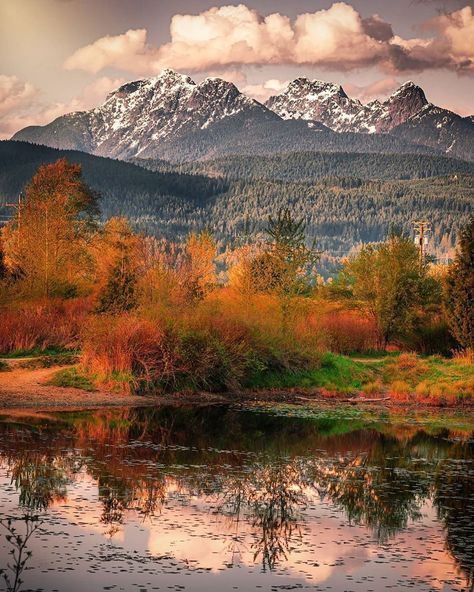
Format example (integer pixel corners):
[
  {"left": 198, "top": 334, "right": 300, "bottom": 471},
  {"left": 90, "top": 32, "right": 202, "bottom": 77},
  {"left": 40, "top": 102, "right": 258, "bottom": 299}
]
[{"left": 0, "top": 364, "right": 153, "bottom": 407}]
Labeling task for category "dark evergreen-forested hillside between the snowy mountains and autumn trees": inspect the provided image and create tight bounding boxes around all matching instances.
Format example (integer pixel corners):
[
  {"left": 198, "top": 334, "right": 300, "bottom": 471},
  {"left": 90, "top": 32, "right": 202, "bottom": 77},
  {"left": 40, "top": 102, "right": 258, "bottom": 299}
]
[{"left": 0, "top": 142, "right": 474, "bottom": 274}]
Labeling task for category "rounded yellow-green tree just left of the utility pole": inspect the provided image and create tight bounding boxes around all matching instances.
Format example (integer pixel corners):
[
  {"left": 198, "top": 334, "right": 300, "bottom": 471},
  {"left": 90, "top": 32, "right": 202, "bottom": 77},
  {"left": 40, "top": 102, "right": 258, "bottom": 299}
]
[{"left": 341, "top": 235, "right": 431, "bottom": 348}]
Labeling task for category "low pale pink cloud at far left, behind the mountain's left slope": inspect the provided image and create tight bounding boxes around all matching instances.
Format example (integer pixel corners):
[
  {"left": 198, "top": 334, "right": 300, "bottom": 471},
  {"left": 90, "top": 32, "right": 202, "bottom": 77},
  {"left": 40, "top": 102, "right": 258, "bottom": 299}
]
[{"left": 0, "top": 75, "right": 125, "bottom": 140}]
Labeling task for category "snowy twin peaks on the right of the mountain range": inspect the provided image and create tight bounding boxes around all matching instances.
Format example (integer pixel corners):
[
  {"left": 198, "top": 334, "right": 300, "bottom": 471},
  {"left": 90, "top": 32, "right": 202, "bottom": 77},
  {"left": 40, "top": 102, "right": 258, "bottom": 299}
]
[{"left": 265, "top": 78, "right": 428, "bottom": 133}]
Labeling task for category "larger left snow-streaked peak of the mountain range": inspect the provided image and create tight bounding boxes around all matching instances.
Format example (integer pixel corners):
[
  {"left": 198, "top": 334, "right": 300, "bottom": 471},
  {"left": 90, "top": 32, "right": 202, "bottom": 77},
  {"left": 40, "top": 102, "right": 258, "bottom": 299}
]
[{"left": 14, "top": 70, "right": 277, "bottom": 158}]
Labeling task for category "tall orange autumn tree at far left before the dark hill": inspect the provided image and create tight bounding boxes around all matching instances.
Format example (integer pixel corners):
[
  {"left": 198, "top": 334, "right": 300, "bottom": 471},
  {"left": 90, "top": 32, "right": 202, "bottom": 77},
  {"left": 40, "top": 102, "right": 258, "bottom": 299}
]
[{"left": 2, "top": 159, "right": 98, "bottom": 297}]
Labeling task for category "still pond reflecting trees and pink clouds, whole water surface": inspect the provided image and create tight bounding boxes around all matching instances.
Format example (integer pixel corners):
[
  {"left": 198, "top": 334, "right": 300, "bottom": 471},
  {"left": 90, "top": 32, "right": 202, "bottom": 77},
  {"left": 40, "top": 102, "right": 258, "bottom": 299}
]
[{"left": 0, "top": 406, "right": 474, "bottom": 592}]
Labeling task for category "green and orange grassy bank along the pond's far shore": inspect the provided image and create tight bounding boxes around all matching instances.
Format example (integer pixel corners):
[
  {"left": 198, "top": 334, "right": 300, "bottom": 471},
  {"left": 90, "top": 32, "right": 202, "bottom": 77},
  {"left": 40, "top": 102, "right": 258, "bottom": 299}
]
[{"left": 36, "top": 353, "right": 474, "bottom": 406}]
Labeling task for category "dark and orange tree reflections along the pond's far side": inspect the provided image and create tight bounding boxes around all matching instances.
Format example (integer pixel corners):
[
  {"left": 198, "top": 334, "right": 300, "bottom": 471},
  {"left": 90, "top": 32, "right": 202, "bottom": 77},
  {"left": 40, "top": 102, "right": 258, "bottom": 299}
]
[{"left": 0, "top": 406, "right": 474, "bottom": 589}]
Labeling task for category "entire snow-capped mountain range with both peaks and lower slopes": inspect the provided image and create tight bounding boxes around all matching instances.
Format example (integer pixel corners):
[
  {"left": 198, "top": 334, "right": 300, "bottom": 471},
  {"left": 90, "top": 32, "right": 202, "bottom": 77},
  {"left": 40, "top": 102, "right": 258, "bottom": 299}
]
[{"left": 13, "top": 70, "right": 474, "bottom": 161}]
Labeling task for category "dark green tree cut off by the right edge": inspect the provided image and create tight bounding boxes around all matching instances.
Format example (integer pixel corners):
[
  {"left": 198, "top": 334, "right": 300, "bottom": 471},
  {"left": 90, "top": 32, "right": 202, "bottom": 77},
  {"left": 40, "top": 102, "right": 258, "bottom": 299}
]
[{"left": 445, "top": 217, "right": 474, "bottom": 350}]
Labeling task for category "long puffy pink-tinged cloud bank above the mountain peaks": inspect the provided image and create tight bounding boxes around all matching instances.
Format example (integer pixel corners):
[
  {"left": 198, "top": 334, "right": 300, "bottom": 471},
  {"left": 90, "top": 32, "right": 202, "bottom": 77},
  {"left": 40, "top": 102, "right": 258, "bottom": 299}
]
[{"left": 64, "top": 2, "right": 474, "bottom": 74}]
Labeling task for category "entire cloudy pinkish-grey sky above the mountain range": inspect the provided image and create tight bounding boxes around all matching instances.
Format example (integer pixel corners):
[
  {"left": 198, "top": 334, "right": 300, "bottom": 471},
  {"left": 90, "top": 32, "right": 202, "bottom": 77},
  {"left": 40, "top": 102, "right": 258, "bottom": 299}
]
[{"left": 0, "top": 0, "right": 474, "bottom": 139}]
